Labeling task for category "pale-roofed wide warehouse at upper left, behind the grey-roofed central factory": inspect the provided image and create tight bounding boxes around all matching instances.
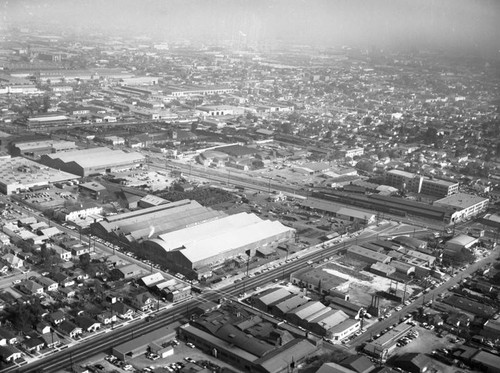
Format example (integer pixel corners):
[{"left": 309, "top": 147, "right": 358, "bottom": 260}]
[{"left": 40, "top": 147, "right": 145, "bottom": 176}]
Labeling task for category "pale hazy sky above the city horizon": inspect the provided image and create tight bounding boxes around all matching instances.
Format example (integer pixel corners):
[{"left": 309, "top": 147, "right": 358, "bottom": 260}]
[{"left": 3, "top": 0, "right": 500, "bottom": 53}]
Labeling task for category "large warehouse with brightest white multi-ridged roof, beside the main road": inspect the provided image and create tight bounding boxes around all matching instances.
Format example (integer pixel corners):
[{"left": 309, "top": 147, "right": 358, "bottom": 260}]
[{"left": 144, "top": 212, "right": 295, "bottom": 277}]
